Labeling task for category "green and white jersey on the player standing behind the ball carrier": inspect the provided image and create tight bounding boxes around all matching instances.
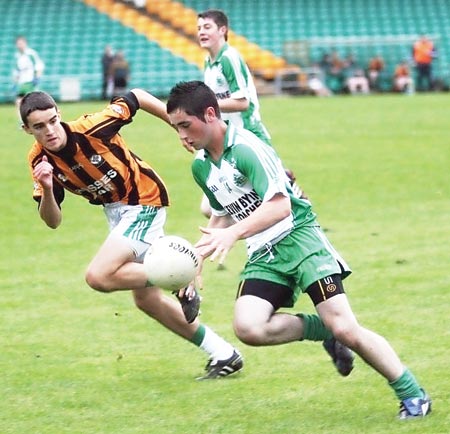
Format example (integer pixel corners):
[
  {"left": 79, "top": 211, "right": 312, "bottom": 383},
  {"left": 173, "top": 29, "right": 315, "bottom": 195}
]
[{"left": 204, "top": 44, "right": 270, "bottom": 144}]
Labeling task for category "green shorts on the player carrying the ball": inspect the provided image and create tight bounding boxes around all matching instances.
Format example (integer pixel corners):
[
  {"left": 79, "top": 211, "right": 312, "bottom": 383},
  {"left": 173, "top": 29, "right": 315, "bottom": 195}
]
[{"left": 241, "top": 225, "right": 351, "bottom": 307}]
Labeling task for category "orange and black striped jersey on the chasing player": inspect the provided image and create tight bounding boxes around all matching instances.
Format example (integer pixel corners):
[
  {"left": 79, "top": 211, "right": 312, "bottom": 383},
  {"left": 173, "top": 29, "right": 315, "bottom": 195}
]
[{"left": 28, "top": 92, "right": 169, "bottom": 207}]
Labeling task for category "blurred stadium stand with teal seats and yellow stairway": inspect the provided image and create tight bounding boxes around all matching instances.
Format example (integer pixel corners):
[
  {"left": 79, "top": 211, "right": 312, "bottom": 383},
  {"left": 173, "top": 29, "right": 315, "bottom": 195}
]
[{"left": 0, "top": 0, "right": 450, "bottom": 102}]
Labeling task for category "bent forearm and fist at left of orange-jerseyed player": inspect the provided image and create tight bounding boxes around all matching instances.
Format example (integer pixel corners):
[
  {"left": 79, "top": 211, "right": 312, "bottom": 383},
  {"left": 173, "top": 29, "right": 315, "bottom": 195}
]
[{"left": 33, "top": 156, "right": 62, "bottom": 229}]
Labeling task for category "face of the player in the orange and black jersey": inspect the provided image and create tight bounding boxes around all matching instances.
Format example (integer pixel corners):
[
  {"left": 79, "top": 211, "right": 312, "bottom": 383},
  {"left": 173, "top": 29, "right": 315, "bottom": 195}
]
[{"left": 23, "top": 108, "right": 67, "bottom": 152}]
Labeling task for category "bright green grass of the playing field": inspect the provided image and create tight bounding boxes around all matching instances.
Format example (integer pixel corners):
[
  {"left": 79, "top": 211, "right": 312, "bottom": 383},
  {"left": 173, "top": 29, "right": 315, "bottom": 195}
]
[{"left": 0, "top": 95, "right": 450, "bottom": 434}]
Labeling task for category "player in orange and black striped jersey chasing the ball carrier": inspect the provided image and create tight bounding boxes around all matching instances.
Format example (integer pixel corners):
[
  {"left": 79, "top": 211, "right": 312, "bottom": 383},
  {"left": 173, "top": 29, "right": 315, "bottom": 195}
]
[{"left": 20, "top": 89, "right": 243, "bottom": 378}]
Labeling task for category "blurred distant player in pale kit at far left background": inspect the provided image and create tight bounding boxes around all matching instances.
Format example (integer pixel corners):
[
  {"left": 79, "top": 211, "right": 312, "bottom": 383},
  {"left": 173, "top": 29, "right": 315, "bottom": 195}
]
[{"left": 13, "top": 35, "right": 45, "bottom": 117}]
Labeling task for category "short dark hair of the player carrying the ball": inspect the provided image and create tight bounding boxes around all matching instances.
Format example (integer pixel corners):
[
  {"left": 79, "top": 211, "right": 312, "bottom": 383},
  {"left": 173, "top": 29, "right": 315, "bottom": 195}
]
[{"left": 167, "top": 80, "right": 220, "bottom": 122}]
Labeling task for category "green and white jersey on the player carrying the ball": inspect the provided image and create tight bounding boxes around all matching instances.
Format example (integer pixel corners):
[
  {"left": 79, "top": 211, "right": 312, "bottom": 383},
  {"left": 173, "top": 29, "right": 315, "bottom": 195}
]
[{"left": 192, "top": 122, "right": 315, "bottom": 257}]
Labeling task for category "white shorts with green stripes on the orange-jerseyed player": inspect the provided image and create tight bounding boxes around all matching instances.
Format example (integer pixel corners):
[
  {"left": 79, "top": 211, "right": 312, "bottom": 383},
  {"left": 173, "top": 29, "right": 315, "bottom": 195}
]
[{"left": 103, "top": 202, "right": 166, "bottom": 262}]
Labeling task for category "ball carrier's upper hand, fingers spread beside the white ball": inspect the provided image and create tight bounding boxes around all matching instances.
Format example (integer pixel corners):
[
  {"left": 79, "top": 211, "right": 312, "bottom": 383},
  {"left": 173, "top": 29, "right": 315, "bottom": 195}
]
[{"left": 195, "top": 226, "right": 238, "bottom": 265}]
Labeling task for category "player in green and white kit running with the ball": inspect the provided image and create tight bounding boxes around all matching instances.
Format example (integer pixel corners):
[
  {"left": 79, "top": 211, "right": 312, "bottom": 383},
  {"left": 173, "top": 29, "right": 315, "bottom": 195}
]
[{"left": 167, "top": 81, "right": 431, "bottom": 419}]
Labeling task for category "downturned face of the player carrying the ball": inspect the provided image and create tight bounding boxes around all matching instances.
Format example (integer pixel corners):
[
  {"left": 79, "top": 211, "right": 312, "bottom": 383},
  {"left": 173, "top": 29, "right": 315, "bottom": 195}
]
[{"left": 169, "top": 109, "right": 214, "bottom": 151}]
